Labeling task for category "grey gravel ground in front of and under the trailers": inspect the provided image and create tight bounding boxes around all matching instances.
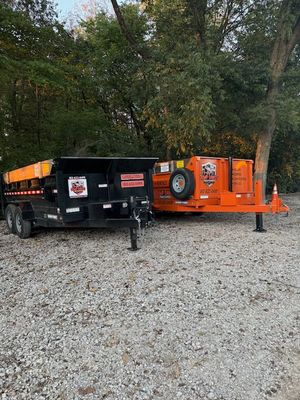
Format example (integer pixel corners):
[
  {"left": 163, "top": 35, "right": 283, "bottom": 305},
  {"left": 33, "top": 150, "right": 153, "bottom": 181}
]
[{"left": 0, "top": 194, "right": 300, "bottom": 400}]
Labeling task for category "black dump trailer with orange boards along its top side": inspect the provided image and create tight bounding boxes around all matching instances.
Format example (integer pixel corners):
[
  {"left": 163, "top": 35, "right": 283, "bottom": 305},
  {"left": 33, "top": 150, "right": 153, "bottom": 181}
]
[{"left": 1, "top": 157, "right": 157, "bottom": 250}]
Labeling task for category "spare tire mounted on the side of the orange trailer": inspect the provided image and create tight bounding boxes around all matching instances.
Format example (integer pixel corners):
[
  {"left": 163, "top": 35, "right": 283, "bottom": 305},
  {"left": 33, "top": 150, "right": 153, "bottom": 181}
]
[{"left": 170, "top": 168, "right": 195, "bottom": 200}]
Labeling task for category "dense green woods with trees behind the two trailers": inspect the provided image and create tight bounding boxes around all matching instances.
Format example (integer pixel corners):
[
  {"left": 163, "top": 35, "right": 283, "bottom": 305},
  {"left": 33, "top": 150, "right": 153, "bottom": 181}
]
[{"left": 0, "top": 0, "right": 300, "bottom": 191}]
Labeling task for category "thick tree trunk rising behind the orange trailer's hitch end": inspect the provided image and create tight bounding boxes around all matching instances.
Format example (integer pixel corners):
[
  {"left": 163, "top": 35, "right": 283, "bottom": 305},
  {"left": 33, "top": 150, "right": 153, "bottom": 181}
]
[{"left": 254, "top": 0, "right": 300, "bottom": 199}]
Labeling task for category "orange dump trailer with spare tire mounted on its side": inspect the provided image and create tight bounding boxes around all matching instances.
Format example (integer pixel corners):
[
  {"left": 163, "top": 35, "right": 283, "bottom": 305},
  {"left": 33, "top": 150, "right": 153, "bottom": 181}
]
[{"left": 153, "top": 156, "right": 289, "bottom": 232}]
